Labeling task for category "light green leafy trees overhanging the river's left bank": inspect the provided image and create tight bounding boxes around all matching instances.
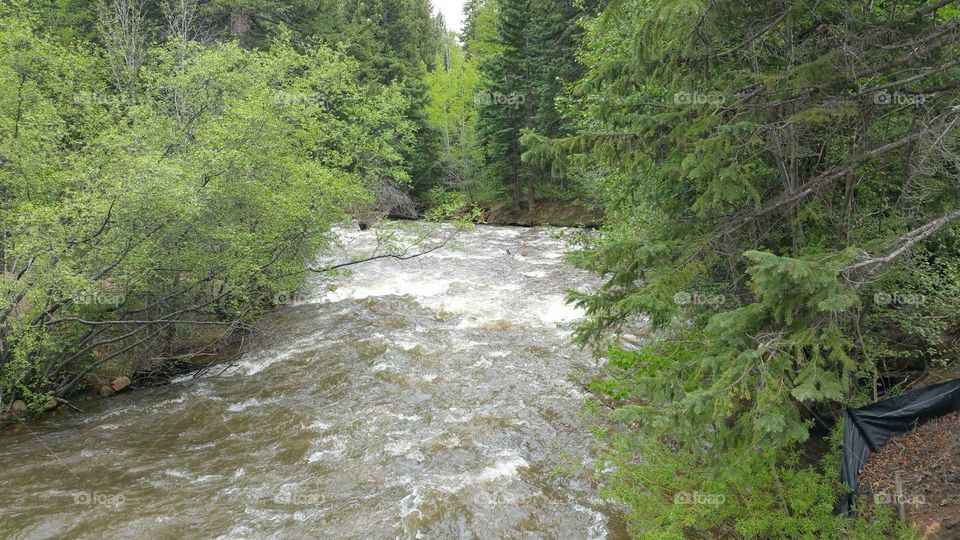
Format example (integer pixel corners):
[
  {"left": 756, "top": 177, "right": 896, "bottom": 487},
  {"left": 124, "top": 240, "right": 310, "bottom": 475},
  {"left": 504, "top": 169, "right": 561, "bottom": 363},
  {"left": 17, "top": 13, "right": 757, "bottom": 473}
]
[{"left": 0, "top": 5, "right": 415, "bottom": 410}]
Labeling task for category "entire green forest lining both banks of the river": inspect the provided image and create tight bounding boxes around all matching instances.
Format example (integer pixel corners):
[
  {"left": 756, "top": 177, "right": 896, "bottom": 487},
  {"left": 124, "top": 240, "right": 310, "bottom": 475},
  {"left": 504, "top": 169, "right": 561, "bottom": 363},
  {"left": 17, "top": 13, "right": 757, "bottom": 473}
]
[{"left": 0, "top": 0, "right": 960, "bottom": 539}]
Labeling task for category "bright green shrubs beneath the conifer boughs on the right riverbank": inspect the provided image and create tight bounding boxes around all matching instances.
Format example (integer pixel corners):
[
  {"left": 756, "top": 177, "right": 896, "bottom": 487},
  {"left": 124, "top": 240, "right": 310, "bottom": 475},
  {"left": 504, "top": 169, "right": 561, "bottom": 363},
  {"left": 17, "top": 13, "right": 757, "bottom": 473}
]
[{"left": 592, "top": 342, "right": 911, "bottom": 539}]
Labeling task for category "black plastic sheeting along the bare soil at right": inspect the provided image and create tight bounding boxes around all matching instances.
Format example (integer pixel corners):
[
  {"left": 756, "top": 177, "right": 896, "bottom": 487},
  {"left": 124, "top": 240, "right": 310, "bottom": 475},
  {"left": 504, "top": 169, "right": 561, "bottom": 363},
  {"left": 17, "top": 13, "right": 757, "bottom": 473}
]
[{"left": 837, "top": 379, "right": 960, "bottom": 515}]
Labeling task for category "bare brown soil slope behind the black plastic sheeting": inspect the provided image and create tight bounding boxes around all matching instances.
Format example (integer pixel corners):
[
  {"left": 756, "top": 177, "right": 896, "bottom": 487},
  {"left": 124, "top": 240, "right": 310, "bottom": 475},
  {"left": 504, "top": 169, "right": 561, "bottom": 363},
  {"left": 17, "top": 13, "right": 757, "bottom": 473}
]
[{"left": 860, "top": 411, "right": 960, "bottom": 539}]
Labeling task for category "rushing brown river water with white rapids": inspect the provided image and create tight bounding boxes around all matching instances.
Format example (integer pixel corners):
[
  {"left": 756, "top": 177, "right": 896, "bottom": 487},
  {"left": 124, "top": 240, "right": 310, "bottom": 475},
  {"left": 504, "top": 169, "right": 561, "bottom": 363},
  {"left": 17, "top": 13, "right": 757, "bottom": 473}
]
[{"left": 0, "top": 227, "right": 621, "bottom": 539}]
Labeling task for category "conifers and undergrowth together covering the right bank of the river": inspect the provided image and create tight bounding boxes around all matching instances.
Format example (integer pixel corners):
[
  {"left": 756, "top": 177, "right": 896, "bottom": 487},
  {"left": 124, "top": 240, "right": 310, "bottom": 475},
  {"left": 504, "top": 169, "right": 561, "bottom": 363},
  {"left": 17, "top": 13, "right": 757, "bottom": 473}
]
[{"left": 568, "top": 0, "right": 960, "bottom": 537}]
